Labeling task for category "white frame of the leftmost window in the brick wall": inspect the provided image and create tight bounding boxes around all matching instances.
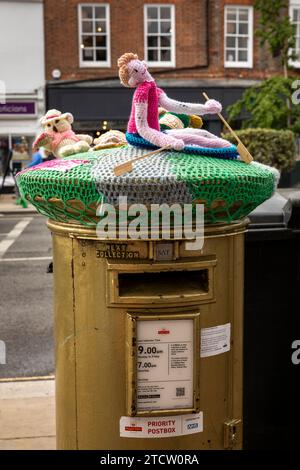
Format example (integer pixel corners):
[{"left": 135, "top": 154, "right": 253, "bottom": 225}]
[{"left": 77, "top": 3, "right": 111, "bottom": 68}]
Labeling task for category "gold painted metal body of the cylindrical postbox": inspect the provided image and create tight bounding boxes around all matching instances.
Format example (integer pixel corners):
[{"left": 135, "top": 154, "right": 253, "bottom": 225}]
[{"left": 48, "top": 221, "right": 247, "bottom": 450}]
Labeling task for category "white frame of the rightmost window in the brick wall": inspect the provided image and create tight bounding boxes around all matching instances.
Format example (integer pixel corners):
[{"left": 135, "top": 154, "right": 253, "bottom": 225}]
[{"left": 224, "top": 4, "right": 254, "bottom": 69}]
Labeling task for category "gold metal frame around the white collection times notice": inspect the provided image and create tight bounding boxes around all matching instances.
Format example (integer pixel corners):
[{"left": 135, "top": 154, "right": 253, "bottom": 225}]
[{"left": 126, "top": 312, "right": 201, "bottom": 416}]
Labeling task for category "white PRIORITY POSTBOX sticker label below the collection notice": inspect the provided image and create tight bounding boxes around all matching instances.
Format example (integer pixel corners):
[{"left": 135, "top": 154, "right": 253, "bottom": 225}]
[{"left": 120, "top": 411, "right": 203, "bottom": 438}]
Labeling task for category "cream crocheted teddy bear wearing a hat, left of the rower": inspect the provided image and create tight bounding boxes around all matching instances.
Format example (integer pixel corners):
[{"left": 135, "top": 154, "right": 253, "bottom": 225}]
[{"left": 33, "top": 109, "right": 93, "bottom": 158}]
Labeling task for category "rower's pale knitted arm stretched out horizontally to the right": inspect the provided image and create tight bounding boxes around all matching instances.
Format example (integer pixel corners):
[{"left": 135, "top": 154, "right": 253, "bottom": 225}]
[{"left": 159, "top": 92, "right": 222, "bottom": 115}]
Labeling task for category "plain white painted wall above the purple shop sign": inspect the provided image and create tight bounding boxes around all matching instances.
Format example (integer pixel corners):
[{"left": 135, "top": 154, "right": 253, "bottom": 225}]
[{"left": 0, "top": 0, "right": 45, "bottom": 94}]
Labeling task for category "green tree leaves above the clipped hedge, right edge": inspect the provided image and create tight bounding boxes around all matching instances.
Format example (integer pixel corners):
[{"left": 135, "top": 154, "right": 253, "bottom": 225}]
[{"left": 227, "top": 4, "right": 300, "bottom": 135}]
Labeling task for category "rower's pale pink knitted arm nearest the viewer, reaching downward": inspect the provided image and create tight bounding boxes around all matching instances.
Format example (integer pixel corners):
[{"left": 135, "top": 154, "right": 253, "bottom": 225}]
[{"left": 135, "top": 103, "right": 184, "bottom": 150}]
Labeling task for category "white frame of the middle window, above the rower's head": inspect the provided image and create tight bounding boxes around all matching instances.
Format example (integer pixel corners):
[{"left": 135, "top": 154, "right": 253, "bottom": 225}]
[{"left": 144, "top": 3, "right": 176, "bottom": 67}]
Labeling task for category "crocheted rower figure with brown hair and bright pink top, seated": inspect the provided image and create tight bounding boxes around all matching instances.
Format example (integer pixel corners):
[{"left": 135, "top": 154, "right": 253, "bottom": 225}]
[{"left": 118, "top": 52, "right": 231, "bottom": 150}]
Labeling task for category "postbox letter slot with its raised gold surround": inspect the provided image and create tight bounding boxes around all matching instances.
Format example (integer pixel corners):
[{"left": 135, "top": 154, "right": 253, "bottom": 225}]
[{"left": 107, "top": 256, "right": 217, "bottom": 306}]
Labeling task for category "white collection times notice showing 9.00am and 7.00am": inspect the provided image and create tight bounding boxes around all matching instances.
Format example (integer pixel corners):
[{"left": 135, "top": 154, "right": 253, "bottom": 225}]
[{"left": 136, "top": 319, "right": 194, "bottom": 411}]
